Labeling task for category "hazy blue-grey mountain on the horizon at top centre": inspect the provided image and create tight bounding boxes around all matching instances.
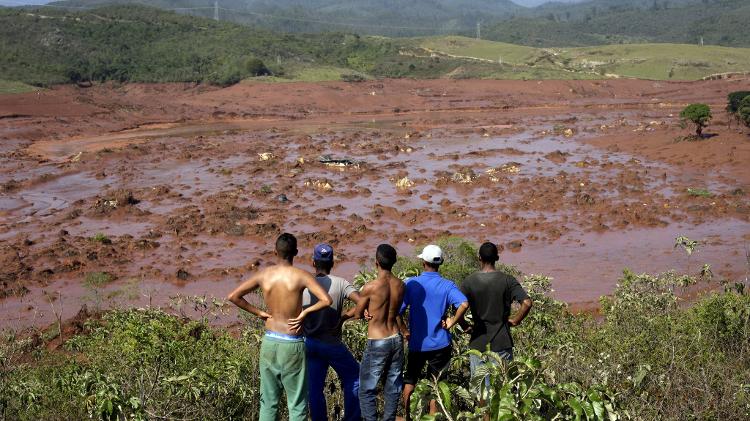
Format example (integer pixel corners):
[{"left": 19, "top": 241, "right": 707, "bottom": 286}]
[{"left": 54, "top": 0, "right": 525, "bottom": 36}]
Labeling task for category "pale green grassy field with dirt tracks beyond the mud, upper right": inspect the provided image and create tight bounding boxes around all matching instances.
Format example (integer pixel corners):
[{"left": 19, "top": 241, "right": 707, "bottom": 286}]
[{"left": 413, "top": 36, "right": 750, "bottom": 80}]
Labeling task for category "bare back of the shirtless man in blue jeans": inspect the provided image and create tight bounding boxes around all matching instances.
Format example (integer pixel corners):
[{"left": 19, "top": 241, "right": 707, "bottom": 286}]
[{"left": 361, "top": 272, "right": 405, "bottom": 339}]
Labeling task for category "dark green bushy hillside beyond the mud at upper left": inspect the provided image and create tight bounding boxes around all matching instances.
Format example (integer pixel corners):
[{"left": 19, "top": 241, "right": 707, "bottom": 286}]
[{"left": 0, "top": 6, "right": 412, "bottom": 85}]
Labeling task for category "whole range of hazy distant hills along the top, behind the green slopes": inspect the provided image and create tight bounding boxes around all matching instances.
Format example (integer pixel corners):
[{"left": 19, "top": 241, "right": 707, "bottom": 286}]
[{"left": 47, "top": 0, "right": 750, "bottom": 47}]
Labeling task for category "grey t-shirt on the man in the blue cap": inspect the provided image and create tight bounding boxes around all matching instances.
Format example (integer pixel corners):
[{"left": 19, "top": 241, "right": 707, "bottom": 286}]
[{"left": 302, "top": 275, "right": 357, "bottom": 343}]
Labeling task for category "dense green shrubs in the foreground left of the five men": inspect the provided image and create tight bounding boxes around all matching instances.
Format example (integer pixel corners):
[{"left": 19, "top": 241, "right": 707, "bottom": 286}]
[{"left": 0, "top": 310, "right": 259, "bottom": 420}]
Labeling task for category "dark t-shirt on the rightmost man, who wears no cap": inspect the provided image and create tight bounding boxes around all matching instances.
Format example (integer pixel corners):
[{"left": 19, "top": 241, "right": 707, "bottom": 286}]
[{"left": 461, "top": 272, "right": 529, "bottom": 352}]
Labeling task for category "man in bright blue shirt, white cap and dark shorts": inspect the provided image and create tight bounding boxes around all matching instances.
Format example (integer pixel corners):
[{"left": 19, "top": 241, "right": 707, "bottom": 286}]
[{"left": 401, "top": 245, "right": 469, "bottom": 420}]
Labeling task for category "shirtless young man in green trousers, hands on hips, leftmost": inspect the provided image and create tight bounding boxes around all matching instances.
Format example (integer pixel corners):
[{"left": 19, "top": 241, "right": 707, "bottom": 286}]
[{"left": 227, "top": 233, "right": 332, "bottom": 421}]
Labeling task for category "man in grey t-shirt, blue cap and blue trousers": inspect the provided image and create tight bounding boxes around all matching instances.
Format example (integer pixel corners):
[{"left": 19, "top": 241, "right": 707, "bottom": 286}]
[{"left": 302, "top": 244, "right": 361, "bottom": 421}]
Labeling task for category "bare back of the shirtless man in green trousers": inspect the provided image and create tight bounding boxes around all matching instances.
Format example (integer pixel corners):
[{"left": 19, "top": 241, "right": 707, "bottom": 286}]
[{"left": 258, "top": 265, "right": 312, "bottom": 335}]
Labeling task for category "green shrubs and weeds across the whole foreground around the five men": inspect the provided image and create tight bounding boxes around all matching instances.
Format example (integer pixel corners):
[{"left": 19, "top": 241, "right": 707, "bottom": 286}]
[{"left": 0, "top": 238, "right": 750, "bottom": 421}]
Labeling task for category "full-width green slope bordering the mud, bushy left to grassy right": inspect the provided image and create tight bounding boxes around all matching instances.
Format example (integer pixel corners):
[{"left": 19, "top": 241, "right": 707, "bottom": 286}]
[{"left": 0, "top": 5, "right": 750, "bottom": 88}]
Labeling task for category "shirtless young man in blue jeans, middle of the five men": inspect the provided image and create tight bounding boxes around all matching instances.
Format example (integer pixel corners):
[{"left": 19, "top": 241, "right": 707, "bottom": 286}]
[{"left": 354, "top": 244, "right": 404, "bottom": 421}]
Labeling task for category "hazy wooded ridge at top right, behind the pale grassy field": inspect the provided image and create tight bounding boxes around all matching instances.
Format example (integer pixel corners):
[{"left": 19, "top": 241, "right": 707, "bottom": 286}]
[{"left": 482, "top": 0, "right": 750, "bottom": 47}]
